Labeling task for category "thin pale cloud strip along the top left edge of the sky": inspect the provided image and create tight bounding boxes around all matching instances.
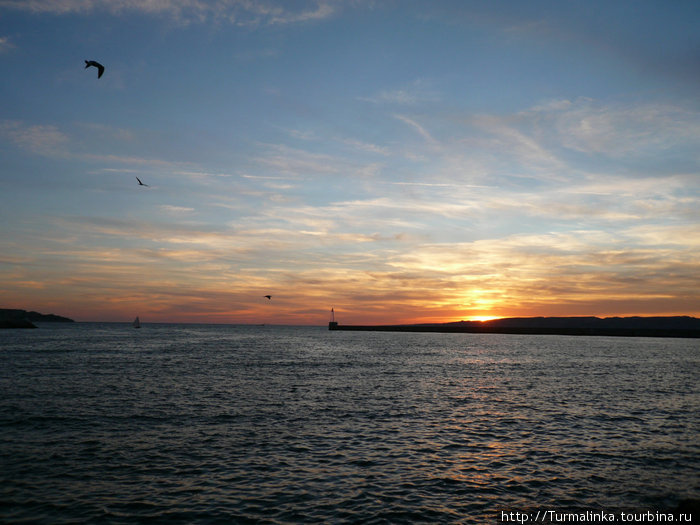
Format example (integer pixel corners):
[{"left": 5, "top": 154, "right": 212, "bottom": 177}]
[{"left": 0, "top": 0, "right": 337, "bottom": 26}]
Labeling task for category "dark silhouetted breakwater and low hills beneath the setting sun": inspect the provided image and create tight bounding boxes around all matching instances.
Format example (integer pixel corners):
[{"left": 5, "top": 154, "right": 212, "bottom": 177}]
[{"left": 328, "top": 317, "right": 700, "bottom": 338}]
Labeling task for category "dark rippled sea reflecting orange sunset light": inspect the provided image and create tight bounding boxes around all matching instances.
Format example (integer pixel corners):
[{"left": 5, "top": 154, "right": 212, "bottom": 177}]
[{"left": 0, "top": 323, "right": 700, "bottom": 524}]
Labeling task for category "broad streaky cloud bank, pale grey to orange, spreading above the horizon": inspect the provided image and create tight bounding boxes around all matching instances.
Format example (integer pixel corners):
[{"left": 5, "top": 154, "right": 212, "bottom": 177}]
[{"left": 0, "top": 93, "right": 700, "bottom": 322}]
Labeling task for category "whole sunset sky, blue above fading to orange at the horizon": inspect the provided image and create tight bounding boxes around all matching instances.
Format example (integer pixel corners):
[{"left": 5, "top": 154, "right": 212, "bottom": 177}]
[{"left": 0, "top": 0, "right": 700, "bottom": 325}]
